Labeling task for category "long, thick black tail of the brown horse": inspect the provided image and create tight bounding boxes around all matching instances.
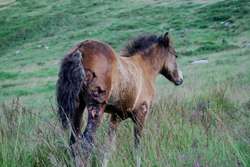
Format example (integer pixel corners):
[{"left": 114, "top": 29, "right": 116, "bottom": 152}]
[{"left": 56, "top": 49, "right": 85, "bottom": 128}]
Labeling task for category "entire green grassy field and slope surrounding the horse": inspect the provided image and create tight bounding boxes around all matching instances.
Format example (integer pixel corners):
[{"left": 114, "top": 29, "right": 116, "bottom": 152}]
[{"left": 0, "top": 0, "right": 250, "bottom": 166}]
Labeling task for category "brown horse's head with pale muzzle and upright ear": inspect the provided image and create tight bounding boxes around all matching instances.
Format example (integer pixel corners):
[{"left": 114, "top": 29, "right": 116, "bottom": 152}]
[{"left": 160, "top": 32, "right": 184, "bottom": 85}]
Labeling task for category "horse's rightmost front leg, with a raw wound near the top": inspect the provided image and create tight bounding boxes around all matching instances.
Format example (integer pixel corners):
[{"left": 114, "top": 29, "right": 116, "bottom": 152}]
[{"left": 132, "top": 103, "right": 148, "bottom": 166}]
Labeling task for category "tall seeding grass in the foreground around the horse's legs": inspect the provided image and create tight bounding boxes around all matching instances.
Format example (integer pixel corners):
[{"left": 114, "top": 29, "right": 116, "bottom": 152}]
[{"left": 0, "top": 78, "right": 250, "bottom": 166}]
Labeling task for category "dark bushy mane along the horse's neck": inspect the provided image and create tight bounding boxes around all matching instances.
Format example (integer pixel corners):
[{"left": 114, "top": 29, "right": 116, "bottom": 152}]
[{"left": 121, "top": 34, "right": 170, "bottom": 57}]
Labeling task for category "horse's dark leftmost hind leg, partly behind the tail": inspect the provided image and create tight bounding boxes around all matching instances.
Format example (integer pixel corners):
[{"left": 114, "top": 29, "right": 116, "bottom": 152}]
[{"left": 70, "top": 93, "right": 86, "bottom": 157}]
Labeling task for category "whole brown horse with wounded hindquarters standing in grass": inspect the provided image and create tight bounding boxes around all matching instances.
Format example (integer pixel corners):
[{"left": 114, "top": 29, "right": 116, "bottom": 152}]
[{"left": 57, "top": 32, "right": 183, "bottom": 166}]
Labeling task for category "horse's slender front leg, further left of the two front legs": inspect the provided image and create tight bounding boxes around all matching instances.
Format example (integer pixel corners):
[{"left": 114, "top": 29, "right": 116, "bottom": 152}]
[{"left": 102, "top": 114, "right": 122, "bottom": 167}]
